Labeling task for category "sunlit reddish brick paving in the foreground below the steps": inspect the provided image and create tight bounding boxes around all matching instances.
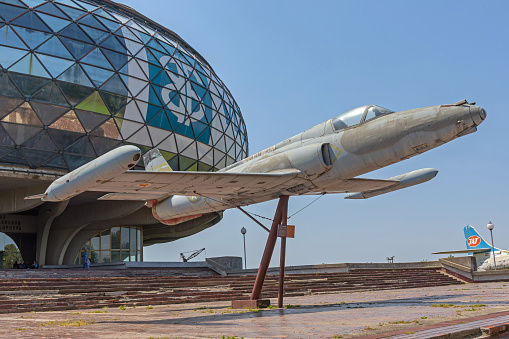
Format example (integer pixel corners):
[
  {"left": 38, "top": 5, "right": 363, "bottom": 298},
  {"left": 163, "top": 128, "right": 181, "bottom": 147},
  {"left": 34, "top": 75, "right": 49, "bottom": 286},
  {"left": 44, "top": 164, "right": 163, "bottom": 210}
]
[{"left": 0, "top": 282, "right": 509, "bottom": 338}]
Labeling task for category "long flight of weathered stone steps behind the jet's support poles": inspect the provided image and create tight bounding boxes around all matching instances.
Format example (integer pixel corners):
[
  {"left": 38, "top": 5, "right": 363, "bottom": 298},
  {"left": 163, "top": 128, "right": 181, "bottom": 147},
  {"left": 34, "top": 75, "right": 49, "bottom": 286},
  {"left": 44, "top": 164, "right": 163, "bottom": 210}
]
[{"left": 0, "top": 268, "right": 462, "bottom": 313}]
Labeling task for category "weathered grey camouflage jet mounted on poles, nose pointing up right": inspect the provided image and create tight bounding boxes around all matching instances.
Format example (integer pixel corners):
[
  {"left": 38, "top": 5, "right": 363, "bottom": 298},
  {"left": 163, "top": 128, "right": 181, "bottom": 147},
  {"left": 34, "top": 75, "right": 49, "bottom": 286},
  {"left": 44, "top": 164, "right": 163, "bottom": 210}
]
[{"left": 26, "top": 100, "right": 486, "bottom": 225}]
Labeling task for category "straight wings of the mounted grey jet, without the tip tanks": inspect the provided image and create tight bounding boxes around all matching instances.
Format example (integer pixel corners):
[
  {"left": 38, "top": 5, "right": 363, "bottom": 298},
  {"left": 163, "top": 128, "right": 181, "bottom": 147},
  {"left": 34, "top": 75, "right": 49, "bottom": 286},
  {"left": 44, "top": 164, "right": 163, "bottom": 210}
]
[{"left": 88, "top": 170, "right": 397, "bottom": 201}]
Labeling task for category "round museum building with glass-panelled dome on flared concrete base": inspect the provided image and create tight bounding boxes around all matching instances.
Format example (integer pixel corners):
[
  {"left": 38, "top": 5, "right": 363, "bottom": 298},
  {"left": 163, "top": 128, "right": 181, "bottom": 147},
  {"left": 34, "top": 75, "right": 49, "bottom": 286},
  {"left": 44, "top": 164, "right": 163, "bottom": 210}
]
[{"left": 0, "top": 0, "right": 248, "bottom": 265}]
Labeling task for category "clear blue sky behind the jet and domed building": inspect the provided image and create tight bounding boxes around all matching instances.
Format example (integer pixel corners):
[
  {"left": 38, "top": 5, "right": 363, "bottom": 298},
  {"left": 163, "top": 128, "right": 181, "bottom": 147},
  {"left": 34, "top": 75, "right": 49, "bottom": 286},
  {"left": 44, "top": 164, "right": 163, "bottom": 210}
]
[{"left": 126, "top": 0, "right": 509, "bottom": 267}]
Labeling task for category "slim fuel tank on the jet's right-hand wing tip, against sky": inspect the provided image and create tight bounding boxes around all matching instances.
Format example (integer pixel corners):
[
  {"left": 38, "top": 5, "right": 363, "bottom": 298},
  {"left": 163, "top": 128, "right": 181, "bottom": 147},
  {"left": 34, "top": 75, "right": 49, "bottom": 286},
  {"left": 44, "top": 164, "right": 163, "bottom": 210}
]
[{"left": 345, "top": 168, "right": 438, "bottom": 199}]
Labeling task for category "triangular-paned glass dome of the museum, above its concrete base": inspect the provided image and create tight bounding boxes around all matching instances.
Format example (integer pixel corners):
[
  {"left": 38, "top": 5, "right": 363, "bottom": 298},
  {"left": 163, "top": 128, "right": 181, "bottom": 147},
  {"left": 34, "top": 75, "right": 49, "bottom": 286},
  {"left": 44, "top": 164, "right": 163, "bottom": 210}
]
[{"left": 0, "top": 0, "right": 248, "bottom": 171}]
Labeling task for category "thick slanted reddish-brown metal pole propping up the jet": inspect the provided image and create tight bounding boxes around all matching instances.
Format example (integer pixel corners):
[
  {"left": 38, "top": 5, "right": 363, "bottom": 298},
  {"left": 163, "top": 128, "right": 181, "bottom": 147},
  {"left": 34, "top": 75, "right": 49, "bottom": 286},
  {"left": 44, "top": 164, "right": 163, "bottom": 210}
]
[{"left": 251, "top": 195, "right": 289, "bottom": 300}]
